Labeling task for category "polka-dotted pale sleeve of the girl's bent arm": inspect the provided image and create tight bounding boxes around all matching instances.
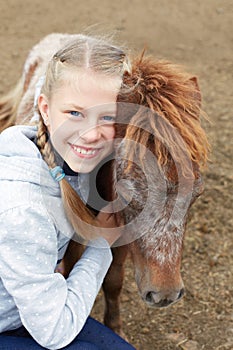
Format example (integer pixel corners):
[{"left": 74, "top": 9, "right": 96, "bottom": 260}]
[{"left": 0, "top": 204, "right": 112, "bottom": 349}]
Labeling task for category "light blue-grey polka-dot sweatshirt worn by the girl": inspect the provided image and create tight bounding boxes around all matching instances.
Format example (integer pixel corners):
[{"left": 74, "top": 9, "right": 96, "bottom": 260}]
[{"left": 0, "top": 126, "right": 112, "bottom": 349}]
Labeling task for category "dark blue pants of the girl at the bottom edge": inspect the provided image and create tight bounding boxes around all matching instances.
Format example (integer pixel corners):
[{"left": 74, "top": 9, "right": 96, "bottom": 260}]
[{"left": 0, "top": 317, "right": 136, "bottom": 350}]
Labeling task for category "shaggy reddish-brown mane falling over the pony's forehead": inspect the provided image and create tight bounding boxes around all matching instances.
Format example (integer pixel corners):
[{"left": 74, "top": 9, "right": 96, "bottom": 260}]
[{"left": 119, "top": 56, "right": 209, "bottom": 179}]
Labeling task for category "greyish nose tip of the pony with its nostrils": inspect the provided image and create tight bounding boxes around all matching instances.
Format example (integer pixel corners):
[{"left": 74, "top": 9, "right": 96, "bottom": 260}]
[{"left": 143, "top": 288, "right": 184, "bottom": 308}]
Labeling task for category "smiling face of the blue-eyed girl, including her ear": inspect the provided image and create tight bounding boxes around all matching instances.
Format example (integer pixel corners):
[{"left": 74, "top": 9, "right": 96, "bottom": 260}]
[{"left": 38, "top": 71, "right": 121, "bottom": 173}]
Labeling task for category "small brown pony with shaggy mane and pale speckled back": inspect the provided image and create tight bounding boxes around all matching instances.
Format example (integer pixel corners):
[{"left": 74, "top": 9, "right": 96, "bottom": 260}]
[{"left": 0, "top": 34, "right": 209, "bottom": 333}]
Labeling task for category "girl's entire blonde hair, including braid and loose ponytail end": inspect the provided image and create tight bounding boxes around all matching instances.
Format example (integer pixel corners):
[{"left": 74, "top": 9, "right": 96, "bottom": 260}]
[{"left": 37, "top": 35, "right": 130, "bottom": 239}]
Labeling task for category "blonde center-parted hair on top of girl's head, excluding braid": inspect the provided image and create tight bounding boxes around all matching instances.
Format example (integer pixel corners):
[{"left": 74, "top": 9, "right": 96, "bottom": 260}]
[{"left": 41, "top": 35, "right": 131, "bottom": 98}]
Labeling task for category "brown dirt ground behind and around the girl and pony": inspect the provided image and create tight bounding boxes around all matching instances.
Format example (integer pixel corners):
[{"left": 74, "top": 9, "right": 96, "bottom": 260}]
[{"left": 0, "top": 0, "right": 233, "bottom": 350}]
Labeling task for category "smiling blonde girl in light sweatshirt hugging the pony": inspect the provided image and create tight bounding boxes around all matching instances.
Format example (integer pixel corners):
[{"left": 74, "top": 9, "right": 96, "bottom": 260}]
[{"left": 0, "top": 35, "right": 136, "bottom": 350}]
